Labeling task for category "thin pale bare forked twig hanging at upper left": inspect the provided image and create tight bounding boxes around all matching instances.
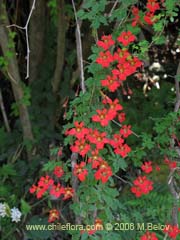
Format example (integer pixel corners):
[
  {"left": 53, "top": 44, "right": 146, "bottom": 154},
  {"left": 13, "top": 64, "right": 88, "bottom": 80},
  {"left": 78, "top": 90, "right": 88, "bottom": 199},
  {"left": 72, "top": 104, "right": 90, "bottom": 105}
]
[{"left": 7, "top": 0, "right": 36, "bottom": 79}]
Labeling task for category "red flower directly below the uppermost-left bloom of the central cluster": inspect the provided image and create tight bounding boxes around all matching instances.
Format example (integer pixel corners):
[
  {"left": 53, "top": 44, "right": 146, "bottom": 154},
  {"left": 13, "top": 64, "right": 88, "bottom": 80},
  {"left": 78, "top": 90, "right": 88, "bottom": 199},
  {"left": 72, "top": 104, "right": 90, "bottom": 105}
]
[{"left": 70, "top": 139, "right": 90, "bottom": 157}]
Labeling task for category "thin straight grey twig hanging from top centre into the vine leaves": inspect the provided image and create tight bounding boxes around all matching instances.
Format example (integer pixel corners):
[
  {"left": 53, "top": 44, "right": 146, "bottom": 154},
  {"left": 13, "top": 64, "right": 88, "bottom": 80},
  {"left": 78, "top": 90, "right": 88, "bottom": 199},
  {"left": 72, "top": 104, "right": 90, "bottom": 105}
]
[{"left": 72, "top": 0, "right": 86, "bottom": 93}]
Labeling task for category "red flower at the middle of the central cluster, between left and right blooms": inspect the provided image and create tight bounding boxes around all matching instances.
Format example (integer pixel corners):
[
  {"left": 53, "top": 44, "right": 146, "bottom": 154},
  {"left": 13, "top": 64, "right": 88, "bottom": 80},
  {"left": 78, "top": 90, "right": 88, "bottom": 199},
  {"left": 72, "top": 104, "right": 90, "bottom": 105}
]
[{"left": 87, "top": 129, "right": 108, "bottom": 149}]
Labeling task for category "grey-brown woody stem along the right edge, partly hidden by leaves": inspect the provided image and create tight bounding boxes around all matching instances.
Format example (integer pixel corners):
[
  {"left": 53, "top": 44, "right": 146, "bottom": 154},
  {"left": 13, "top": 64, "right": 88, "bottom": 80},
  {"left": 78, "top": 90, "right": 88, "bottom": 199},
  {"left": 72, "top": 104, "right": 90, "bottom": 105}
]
[{"left": 168, "top": 62, "right": 180, "bottom": 226}]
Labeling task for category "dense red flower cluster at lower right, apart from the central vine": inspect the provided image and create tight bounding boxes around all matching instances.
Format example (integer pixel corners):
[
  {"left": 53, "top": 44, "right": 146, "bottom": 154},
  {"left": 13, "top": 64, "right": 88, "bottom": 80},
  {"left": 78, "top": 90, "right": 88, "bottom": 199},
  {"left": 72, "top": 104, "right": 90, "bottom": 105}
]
[{"left": 131, "top": 176, "right": 153, "bottom": 197}]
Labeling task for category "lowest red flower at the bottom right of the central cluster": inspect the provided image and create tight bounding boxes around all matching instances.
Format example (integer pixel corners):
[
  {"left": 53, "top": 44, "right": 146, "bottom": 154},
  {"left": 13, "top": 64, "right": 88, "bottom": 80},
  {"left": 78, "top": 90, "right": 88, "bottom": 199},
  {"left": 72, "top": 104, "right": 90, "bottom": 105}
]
[{"left": 94, "top": 161, "right": 112, "bottom": 183}]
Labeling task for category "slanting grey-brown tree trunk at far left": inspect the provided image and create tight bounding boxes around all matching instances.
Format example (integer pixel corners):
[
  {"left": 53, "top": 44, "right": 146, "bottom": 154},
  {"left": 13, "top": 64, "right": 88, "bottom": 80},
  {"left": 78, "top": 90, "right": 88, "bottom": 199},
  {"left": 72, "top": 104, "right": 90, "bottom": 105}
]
[{"left": 0, "top": 1, "right": 33, "bottom": 158}]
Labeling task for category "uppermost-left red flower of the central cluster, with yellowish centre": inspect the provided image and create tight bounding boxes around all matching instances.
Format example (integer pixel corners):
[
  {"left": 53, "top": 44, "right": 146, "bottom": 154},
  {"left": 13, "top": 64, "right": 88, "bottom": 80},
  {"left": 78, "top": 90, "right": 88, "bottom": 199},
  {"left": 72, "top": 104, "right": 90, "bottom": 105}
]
[{"left": 66, "top": 121, "right": 88, "bottom": 139}]
